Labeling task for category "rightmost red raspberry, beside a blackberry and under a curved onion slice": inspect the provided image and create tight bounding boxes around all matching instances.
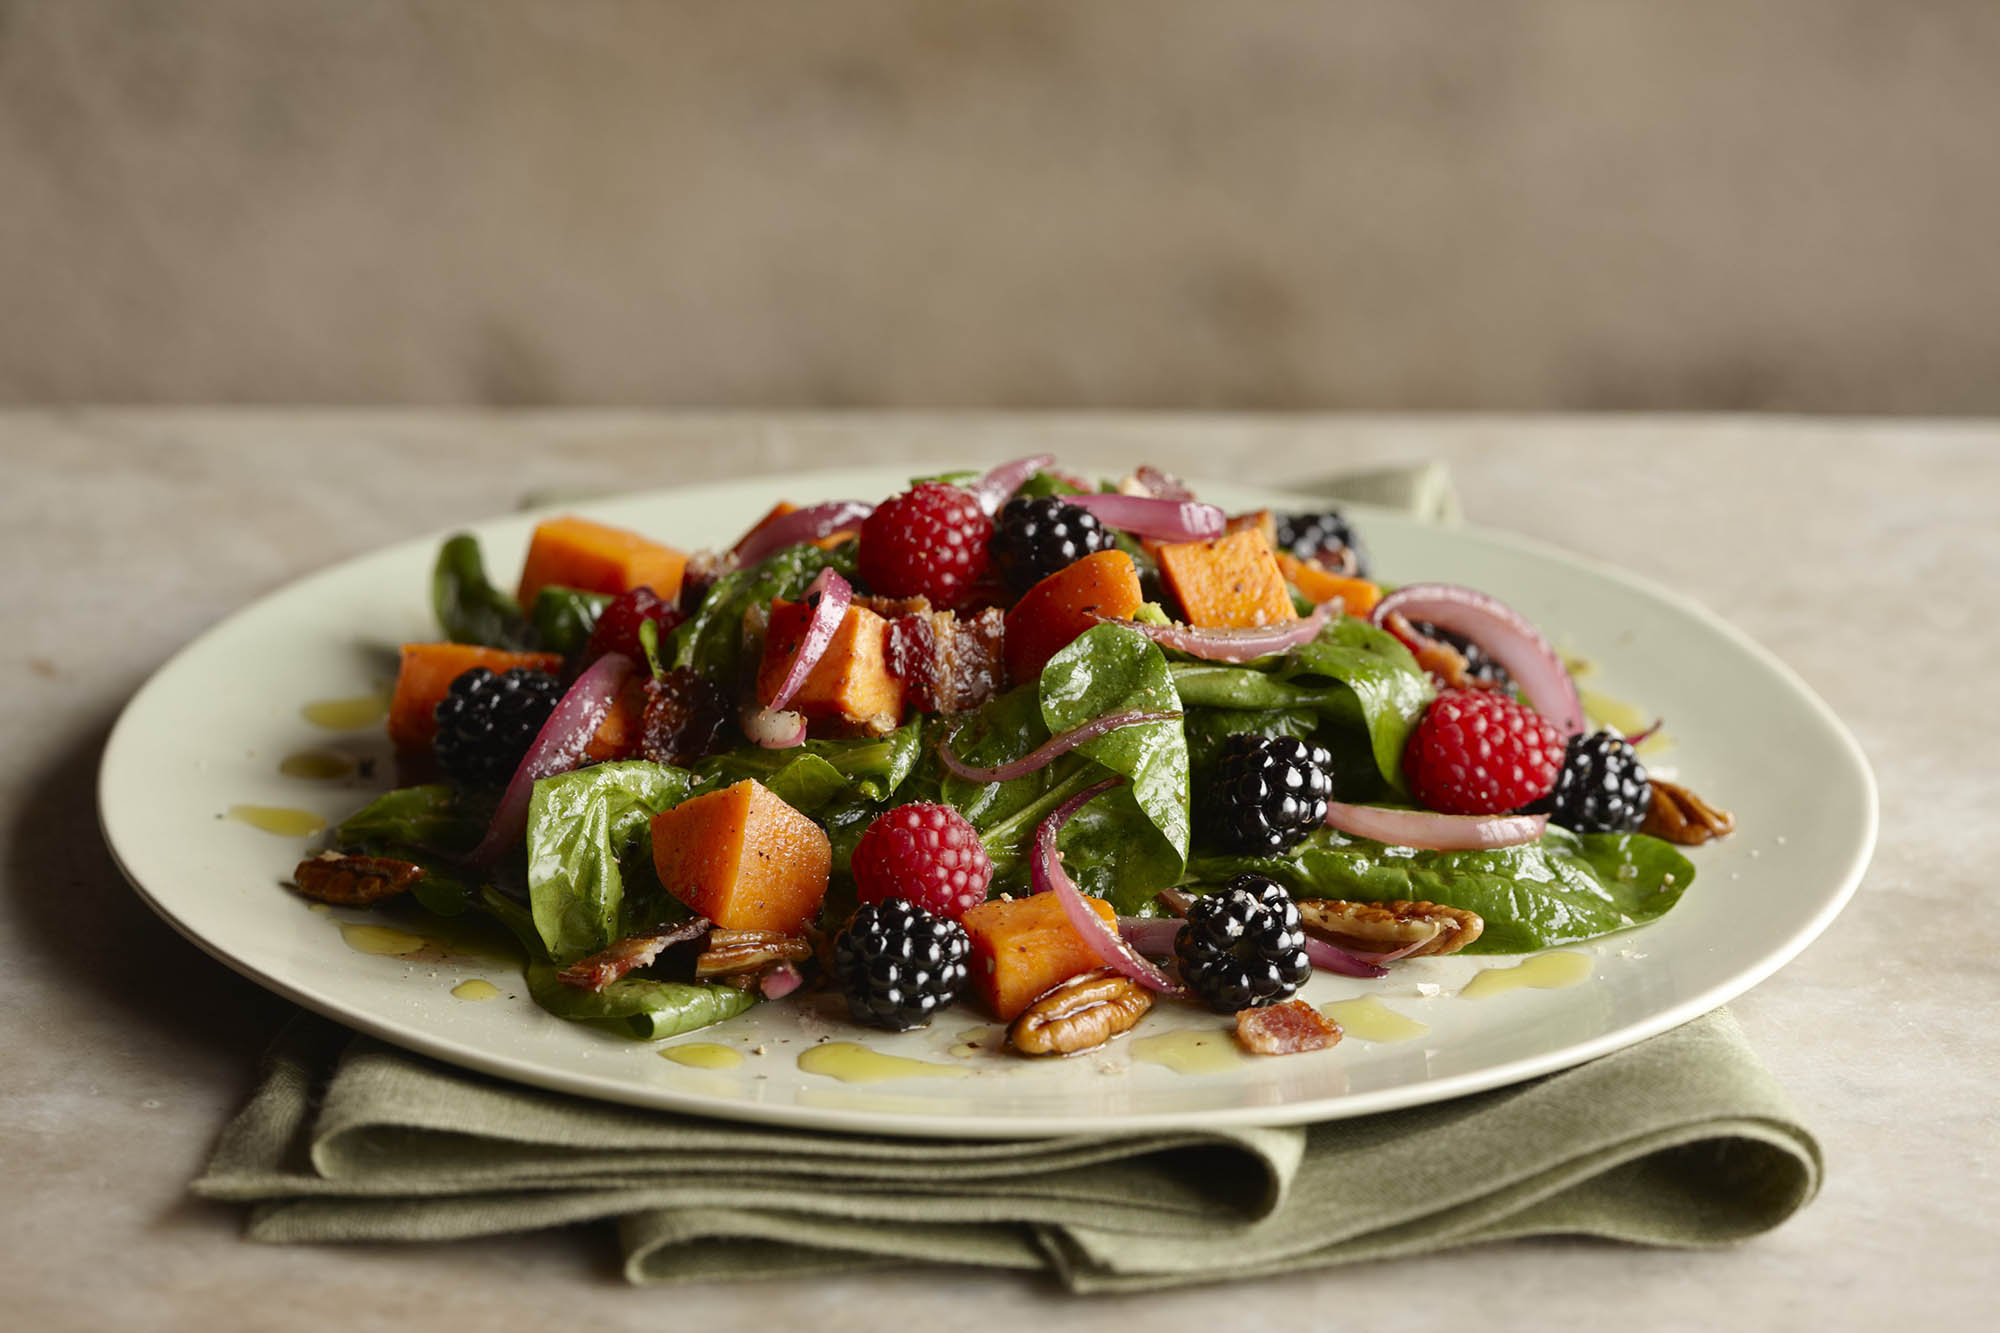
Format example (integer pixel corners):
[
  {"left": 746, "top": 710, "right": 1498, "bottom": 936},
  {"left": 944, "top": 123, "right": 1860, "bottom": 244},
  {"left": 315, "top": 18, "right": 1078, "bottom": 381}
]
[{"left": 1402, "top": 691, "right": 1564, "bottom": 815}]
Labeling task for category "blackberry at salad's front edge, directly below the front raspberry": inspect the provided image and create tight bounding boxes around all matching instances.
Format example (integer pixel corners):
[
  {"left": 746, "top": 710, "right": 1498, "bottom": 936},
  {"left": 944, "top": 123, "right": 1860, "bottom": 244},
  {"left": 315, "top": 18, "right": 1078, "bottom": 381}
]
[{"left": 834, "top": 899, "right": 972, "bottom": 1033}]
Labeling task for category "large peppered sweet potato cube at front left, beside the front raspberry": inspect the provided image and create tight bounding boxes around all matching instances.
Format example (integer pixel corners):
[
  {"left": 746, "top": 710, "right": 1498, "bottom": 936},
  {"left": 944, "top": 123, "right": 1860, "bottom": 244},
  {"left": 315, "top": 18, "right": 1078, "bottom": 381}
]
[{"left": 652, "top": 779, "right": 834, "bottom": 935}]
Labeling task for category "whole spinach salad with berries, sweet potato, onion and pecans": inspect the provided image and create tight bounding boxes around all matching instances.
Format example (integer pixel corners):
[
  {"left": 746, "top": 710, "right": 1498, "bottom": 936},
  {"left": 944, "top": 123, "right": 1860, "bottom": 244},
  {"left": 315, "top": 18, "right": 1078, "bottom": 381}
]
[{"left": 294, "top": 456, "right": 1730, "bottom": 1055}]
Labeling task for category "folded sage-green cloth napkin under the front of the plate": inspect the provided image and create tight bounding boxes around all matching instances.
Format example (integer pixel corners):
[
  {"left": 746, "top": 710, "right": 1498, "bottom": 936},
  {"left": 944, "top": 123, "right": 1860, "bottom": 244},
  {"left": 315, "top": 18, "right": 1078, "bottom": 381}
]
[{"left": 194, "top": 1011, "right": 1820, "bottom": 1291}]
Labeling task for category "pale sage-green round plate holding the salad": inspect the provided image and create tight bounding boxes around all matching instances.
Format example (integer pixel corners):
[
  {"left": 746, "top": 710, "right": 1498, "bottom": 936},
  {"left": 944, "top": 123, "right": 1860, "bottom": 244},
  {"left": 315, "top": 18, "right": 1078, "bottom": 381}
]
[{"left": 98, "top": 468, "right": 1876, "bottom": 1137}]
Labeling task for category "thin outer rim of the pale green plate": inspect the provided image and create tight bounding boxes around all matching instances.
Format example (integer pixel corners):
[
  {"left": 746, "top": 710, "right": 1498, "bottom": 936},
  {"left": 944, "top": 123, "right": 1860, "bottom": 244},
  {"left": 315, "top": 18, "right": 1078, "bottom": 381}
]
[{"left": 94, "top": 460, "right": 1880, "bottom": 1139}]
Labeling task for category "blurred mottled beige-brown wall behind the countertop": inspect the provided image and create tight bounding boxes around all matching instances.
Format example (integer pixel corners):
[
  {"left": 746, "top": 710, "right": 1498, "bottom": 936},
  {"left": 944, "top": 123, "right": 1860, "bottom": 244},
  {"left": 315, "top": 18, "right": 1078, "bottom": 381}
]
[{"left": 0, "top": 0, "right": 2000, "bottom": 412}]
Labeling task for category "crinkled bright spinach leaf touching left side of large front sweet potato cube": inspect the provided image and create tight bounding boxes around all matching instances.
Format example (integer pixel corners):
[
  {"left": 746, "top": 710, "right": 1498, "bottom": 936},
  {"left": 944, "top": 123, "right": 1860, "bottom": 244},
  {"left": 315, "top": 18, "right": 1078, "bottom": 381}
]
[{"left": 528, "top": 759, "right": 694, "bottom": 963}]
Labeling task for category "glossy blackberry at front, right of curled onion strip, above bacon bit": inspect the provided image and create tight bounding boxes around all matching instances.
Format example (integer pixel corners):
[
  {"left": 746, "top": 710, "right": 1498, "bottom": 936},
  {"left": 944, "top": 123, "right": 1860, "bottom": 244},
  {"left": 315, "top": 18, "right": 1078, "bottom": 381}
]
[{"left": 1174, "top": 875, "right": 1312, "bottom": 1013}]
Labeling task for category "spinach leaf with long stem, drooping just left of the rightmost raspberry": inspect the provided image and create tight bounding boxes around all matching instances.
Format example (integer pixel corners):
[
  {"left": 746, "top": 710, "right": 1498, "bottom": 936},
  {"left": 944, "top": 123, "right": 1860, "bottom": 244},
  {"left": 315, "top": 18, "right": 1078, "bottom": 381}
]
[{"left": 1172, "top": 616, "right": 1432, "bottom": 789}]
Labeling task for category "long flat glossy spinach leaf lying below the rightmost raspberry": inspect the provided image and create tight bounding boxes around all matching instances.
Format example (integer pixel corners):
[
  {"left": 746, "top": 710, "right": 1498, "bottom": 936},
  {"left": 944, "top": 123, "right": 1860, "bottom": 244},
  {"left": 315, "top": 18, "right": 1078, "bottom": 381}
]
[{"left": 1188, "top": 827, "right": 1694, "bottom": 953}]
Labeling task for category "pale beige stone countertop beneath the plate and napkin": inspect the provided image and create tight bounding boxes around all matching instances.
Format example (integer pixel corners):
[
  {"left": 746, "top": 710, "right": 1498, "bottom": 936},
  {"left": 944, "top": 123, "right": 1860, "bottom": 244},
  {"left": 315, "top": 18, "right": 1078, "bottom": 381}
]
[{"left": 0, "top": 410, "right": 2000, "bottom": 1333}]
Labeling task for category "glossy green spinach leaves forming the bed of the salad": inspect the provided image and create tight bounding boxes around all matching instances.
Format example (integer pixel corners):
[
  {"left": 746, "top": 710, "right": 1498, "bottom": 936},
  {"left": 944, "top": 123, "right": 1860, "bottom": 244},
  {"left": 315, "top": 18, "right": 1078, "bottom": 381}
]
[{"left": 334, "top": 474, "right": 1694, "bottom": 1039}]
